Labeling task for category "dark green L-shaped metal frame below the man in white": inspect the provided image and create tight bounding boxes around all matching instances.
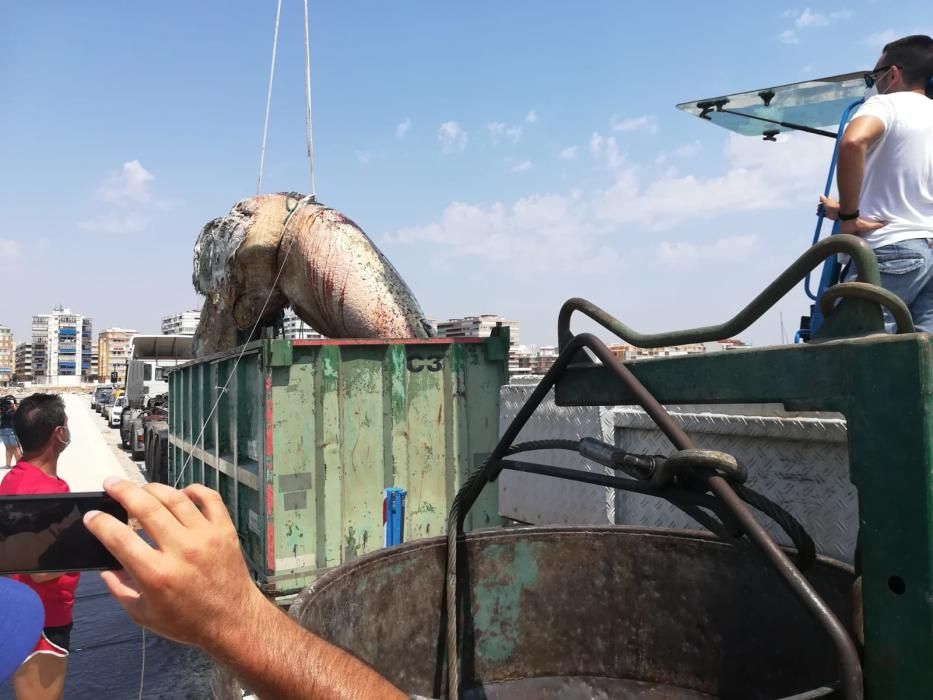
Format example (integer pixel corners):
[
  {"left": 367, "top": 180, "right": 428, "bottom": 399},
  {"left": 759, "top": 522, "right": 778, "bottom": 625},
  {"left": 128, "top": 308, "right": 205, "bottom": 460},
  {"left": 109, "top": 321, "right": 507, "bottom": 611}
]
[{"left": 556, "top": 333, "right": 933, "bottom": 700}]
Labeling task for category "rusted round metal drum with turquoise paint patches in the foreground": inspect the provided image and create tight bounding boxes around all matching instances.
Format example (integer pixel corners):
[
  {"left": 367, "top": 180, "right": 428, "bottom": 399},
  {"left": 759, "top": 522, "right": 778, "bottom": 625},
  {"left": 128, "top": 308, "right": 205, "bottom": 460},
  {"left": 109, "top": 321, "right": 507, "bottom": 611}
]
[{"left": 291, "top": 527, "right": 853, "bottom": 700}]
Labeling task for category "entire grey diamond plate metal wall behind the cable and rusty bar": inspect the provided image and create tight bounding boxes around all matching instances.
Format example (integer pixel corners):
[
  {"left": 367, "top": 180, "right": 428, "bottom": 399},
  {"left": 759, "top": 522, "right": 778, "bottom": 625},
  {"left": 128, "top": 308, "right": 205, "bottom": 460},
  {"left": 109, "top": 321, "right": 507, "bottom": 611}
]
[{"left": 499, "top": 383, "right": 858, "bottom": 563}]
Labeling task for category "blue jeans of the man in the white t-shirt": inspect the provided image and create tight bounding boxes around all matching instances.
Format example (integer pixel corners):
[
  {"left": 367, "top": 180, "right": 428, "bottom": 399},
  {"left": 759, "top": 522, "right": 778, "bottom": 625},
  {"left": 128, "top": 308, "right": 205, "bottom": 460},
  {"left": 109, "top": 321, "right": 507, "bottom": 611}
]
[{"left": 856, "top": 238, "right": 933, "bottom": 333}]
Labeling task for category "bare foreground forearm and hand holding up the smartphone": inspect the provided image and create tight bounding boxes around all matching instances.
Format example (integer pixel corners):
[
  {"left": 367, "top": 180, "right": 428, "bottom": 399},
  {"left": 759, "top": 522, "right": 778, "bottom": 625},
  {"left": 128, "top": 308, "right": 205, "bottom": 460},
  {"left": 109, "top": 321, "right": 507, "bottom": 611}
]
[{"left": 85, "top": 479, "right": 405, "bottom": 700}]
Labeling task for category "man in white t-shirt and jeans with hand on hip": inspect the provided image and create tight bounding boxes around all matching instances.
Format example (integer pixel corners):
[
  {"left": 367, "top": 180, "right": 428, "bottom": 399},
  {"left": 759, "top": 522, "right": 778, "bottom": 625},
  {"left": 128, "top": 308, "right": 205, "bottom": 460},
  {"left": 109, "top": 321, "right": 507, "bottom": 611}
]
[{"left": 820, "top": 35, "right": 933, "bottom": 333}]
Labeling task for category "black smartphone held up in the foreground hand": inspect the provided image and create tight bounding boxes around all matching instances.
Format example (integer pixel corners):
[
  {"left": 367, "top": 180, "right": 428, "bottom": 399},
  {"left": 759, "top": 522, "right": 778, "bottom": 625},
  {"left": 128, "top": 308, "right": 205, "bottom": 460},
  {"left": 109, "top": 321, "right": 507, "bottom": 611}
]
[{"left": 0, "top": 493, "right": 127, "bottom": 574}]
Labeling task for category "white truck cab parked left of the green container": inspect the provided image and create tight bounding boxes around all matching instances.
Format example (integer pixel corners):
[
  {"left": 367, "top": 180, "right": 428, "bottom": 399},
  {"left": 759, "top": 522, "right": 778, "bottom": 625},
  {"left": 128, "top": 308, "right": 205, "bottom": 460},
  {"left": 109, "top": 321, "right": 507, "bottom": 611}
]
[{"left": 120, "top": 335, "right": 193, "bottom": 460}]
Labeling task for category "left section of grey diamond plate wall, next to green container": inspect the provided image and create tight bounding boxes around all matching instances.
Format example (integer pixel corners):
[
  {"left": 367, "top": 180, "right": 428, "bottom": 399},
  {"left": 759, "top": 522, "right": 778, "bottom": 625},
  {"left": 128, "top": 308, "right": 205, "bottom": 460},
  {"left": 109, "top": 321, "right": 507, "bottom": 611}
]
[{"left": 498, "top": 383, "right": 616, "bottom": 525}]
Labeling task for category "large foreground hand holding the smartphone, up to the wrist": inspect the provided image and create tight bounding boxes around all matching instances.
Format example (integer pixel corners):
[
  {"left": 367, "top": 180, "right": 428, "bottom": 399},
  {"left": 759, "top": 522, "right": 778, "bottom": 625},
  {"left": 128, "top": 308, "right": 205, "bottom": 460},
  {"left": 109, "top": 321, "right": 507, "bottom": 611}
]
[{"left": 84, "top": 479, "right": 268, "bottom": 653}]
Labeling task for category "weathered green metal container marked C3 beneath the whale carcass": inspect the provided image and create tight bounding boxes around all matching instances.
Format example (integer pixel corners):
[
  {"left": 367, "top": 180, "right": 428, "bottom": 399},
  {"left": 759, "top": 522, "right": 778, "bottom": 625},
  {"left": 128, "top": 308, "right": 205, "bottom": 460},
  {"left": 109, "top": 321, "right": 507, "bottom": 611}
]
[{"left": 168, "top": 332, "right": 509, "bottom": 595}]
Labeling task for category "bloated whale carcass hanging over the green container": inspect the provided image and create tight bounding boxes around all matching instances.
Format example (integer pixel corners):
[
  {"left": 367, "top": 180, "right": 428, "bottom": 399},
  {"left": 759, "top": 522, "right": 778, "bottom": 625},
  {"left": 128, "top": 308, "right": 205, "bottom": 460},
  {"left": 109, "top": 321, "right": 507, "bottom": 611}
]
[{"left": 193, "top": 194, "right": 431, "bottom": 357}]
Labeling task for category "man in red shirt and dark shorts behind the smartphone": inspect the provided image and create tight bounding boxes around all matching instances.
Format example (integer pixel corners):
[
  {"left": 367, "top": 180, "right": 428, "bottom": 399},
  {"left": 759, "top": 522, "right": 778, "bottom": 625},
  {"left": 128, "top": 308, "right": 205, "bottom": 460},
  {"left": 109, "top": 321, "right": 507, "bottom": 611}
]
[{"left": 0, "top": 394, "right": 79, "bottom": 700}]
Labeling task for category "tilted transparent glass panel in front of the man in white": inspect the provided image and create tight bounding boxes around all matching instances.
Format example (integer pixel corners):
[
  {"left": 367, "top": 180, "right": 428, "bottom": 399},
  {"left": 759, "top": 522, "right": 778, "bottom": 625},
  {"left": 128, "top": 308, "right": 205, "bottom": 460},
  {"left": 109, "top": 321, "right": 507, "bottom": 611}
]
[{"left": 677, "top": 72, "right": 865, "bottom": 136}]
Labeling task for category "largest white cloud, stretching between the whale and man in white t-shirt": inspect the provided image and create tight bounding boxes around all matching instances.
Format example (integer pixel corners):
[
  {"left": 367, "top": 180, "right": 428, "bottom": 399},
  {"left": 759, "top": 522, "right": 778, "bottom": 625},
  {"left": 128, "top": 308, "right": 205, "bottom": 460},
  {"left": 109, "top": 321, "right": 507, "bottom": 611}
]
[{"left": 386, "top": 133, "right": 832, "bottom": 271}]
